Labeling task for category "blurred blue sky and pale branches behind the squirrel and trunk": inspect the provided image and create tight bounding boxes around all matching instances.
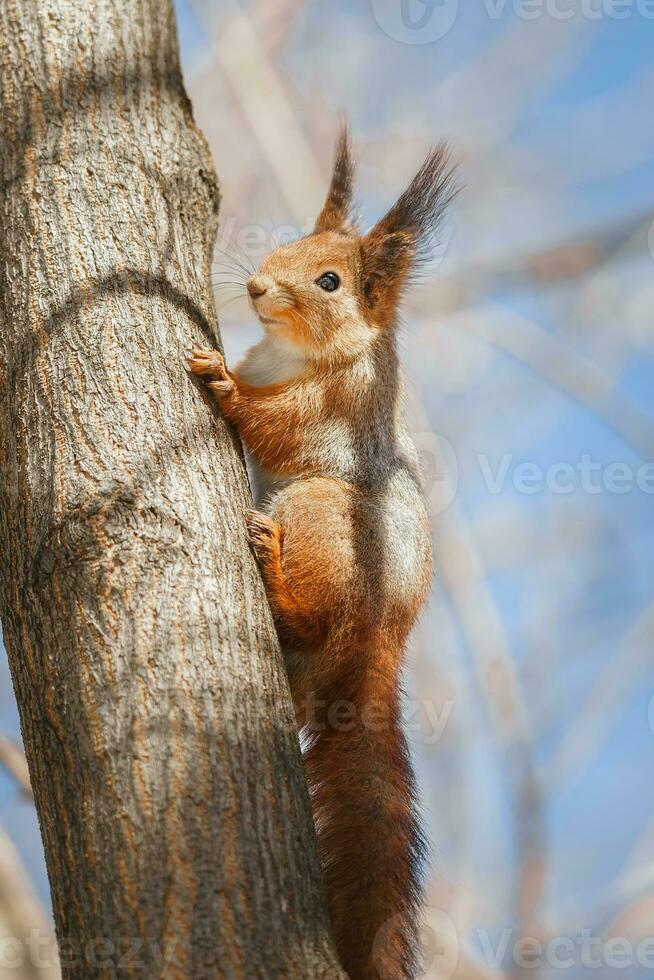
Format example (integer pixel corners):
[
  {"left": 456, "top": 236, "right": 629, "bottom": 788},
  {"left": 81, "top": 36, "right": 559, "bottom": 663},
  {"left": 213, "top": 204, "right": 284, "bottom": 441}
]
[{"left": 0, "top": 0, "right": 654, "bottom": 980}]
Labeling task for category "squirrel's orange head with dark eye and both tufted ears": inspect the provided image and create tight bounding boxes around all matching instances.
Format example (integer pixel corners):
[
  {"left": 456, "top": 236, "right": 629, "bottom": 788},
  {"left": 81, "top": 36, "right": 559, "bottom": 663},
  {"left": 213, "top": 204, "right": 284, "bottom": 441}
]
[{"left": 247, "top": 127, "right": 455, "bottom": 354}]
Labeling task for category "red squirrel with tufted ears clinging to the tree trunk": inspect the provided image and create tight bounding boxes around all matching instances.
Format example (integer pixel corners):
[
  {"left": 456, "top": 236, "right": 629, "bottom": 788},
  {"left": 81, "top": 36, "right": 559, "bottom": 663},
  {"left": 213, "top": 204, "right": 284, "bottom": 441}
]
[{"left": 189, "top": 127, "right": 454, "bottom": 980}]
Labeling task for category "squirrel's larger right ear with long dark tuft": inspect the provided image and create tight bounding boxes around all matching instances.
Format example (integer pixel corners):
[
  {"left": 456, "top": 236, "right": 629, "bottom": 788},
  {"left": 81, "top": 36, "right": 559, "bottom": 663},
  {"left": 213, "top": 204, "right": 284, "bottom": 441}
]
[{"left": 361, "top": 143, "right": 458, "bottom": 325}]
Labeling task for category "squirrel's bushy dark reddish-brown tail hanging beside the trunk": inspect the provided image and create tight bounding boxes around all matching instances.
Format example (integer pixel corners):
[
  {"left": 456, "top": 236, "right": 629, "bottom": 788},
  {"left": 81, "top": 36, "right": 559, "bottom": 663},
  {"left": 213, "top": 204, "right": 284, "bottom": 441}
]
[{"left": 305, "top": 658, "right": 425, "bottom": 980}]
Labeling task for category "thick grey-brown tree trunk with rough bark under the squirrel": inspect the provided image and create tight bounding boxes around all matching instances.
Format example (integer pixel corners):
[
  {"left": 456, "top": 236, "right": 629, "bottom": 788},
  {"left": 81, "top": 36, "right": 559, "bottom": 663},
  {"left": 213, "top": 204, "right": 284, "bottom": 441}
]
[{"left": 0, "top": 0, "right": 343, "bottom": 980}]
